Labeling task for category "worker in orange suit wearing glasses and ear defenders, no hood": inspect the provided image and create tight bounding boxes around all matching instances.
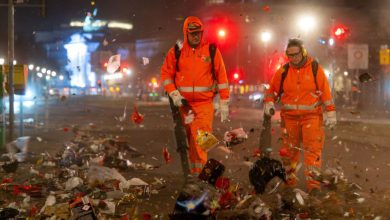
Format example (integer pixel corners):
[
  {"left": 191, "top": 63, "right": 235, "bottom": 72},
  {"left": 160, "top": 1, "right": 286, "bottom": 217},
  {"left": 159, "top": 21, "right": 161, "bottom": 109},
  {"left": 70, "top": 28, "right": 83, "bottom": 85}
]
[{"left": 264, "top": 39, "right": 337, "bottom": 192}]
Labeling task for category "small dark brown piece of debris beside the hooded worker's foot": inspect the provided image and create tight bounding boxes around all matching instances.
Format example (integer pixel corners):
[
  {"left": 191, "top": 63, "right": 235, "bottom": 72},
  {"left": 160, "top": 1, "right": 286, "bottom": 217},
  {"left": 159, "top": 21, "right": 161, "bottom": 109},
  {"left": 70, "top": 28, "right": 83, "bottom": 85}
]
[{"left": 198, "top": 159, "right": 225, "bottom": 186}]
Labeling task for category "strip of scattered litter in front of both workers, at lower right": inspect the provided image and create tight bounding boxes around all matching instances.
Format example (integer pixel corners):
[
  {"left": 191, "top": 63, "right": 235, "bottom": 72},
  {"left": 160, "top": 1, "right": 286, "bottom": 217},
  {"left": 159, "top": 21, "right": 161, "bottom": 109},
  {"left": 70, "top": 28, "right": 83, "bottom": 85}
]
[{"left": 170, "top": 158, "right": 390, "bottom": 220}]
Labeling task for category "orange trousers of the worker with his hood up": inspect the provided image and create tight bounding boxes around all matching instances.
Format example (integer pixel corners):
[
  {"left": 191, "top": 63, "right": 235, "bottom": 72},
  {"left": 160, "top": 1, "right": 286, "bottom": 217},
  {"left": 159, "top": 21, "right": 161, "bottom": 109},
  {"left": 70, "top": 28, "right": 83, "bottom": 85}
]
[{"left": 180, "top": 102, "right": 214, "bottom": 173}]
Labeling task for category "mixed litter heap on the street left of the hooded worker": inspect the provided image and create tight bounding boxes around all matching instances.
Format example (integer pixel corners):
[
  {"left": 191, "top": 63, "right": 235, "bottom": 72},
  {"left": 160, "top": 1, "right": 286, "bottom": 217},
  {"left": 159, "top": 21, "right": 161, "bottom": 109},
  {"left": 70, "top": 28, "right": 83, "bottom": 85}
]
[{"left": 0, "top": 135, "right": 164, "bottom": 219}]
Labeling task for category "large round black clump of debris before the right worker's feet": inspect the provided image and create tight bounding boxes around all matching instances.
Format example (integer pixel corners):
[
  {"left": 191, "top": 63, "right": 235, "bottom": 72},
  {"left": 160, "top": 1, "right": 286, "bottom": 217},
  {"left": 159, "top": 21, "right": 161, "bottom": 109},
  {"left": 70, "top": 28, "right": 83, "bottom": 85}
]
[{"left": 249, "top": 157, "right": 286, "bottom": 194}]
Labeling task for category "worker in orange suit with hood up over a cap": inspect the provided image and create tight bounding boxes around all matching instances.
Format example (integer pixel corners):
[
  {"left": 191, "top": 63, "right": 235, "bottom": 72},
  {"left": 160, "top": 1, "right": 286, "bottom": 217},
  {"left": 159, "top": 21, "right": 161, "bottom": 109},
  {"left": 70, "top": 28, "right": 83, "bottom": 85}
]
[{"left": 161, "top": 16, "right": 229, "bottom": 174}]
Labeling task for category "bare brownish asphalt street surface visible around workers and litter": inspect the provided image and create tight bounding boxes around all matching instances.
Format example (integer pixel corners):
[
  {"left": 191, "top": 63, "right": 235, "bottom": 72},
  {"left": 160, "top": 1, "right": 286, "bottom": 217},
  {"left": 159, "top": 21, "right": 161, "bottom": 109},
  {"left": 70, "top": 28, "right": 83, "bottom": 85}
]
[{"left": 5, "top": 96, "right": 390, "bottom": 217}]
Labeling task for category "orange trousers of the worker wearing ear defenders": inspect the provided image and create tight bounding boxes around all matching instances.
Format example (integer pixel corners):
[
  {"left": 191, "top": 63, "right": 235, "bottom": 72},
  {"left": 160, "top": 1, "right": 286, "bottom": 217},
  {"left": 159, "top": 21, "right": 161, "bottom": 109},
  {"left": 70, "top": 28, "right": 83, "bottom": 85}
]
[{"left": 282, "top": 114, "right": 325, "bottom": 191}]
